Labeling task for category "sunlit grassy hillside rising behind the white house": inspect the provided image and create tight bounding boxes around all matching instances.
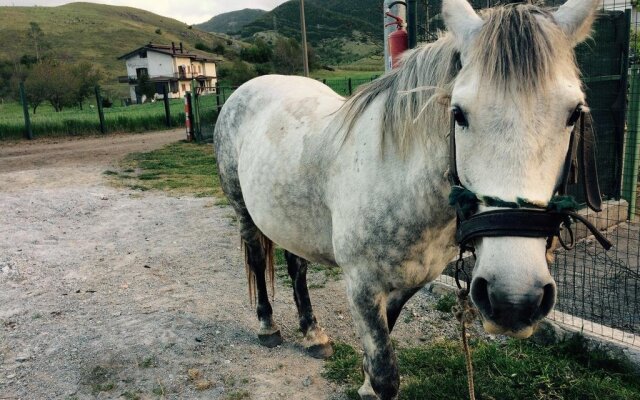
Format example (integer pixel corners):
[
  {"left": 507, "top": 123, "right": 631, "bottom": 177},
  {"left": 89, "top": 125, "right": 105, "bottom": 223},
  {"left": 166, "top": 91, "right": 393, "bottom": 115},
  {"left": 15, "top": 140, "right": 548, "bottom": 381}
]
[{"left": 0, "top": 3, "right": 242, "bottom": 96}]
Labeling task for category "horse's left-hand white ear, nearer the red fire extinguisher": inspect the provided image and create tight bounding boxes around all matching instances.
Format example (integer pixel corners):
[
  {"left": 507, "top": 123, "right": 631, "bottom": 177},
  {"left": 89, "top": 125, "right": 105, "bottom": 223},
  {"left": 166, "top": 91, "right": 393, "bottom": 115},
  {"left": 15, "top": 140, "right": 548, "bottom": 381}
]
[{"left": 442, "top": 0, "right": 483, "bottom": 51}]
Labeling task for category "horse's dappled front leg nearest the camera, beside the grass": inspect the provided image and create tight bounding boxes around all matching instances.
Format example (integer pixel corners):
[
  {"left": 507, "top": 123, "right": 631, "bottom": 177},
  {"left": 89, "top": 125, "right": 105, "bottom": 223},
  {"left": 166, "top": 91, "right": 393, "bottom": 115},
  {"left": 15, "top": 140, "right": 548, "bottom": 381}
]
[{"left": 347, "top": 275, "right": 400, "bottom": 400}]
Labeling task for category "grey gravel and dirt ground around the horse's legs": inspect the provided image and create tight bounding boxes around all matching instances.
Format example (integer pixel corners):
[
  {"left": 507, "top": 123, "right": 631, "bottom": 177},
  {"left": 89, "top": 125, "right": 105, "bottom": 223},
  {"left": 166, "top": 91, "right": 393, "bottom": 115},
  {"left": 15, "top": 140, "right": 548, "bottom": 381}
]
[{"left": 0, "top": 131, "right": 476, "bottom": 399}]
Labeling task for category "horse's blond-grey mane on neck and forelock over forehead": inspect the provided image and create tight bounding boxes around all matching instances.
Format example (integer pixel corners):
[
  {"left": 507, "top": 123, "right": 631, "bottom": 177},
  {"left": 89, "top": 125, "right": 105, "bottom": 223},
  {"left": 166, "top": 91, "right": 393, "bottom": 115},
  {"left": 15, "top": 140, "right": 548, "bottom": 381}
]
[{"left": 340, "top": 4, "right": 578, "bottom": 153}]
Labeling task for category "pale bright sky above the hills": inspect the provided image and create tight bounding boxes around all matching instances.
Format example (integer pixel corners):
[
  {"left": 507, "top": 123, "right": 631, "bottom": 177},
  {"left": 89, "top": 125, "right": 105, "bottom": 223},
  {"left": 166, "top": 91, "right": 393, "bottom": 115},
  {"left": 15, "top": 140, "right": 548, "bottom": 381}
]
[{"left": 0, "top": 0, "right": 287, "bottom": 24}]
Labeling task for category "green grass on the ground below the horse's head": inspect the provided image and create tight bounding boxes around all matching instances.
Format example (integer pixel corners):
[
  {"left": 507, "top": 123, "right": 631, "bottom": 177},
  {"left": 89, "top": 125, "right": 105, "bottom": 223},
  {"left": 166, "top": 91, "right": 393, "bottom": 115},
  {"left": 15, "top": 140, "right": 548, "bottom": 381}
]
[{"left": 323, "top": 336, "right": 640, "bottom": 400}]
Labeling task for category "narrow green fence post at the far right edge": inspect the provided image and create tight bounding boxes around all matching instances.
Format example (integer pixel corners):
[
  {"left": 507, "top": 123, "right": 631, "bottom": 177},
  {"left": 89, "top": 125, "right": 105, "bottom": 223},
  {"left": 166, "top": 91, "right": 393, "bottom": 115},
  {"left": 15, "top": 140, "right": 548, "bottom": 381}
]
[{"left": 622, "top": 65, "right": 640, "bottom": 220}]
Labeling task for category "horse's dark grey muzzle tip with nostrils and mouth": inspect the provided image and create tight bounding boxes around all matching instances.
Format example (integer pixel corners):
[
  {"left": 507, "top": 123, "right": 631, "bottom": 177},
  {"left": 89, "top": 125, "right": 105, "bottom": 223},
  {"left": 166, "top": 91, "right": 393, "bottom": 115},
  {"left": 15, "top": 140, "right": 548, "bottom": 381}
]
[{"left": 471, "top": 277, "right": 556, "bottom": 338}]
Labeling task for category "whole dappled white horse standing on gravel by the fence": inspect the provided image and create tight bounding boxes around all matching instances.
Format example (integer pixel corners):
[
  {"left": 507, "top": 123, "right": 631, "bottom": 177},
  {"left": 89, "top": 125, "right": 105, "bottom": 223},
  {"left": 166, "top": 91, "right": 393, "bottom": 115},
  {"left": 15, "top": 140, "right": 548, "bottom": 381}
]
[{"left": 214, "top": 0, "right": 599, "bottom": 399}]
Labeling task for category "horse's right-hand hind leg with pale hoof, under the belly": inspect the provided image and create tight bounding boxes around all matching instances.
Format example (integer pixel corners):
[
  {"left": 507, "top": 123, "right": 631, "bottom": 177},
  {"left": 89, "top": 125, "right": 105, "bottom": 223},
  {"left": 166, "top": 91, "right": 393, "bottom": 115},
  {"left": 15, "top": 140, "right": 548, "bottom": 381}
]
[{"left": 284, "top": 250, "right": 333, "bottom": 358}]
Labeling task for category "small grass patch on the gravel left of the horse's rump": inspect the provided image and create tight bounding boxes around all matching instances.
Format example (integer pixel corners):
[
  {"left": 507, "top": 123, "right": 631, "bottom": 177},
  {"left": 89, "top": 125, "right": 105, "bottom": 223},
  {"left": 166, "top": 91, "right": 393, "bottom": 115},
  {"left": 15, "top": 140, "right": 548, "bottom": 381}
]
[{"left": 112, "top": 141, "right": 224, "bottom": 199}]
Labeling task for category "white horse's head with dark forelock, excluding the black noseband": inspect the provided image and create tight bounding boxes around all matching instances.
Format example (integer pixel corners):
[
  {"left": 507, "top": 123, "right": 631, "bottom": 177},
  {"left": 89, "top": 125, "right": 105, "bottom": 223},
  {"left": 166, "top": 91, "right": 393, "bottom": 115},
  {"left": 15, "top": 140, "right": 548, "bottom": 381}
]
[{"left": 443, "top": 0, "right": 599, "bottom": 337}]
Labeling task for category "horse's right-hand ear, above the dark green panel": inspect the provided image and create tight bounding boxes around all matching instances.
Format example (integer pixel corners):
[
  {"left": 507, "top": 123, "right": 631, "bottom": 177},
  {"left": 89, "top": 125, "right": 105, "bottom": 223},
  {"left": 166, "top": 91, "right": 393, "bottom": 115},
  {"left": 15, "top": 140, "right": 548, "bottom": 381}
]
[{"left": 553, "top": 0, "right": 601, "bottom": 45}]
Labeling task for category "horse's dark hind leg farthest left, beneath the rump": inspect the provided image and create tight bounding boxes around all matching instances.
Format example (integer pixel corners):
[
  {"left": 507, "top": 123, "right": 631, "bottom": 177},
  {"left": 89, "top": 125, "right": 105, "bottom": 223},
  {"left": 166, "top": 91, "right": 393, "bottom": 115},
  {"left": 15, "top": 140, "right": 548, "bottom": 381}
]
[{"left": 238, "top": 216, "right": 282, "bottom": 347}]
